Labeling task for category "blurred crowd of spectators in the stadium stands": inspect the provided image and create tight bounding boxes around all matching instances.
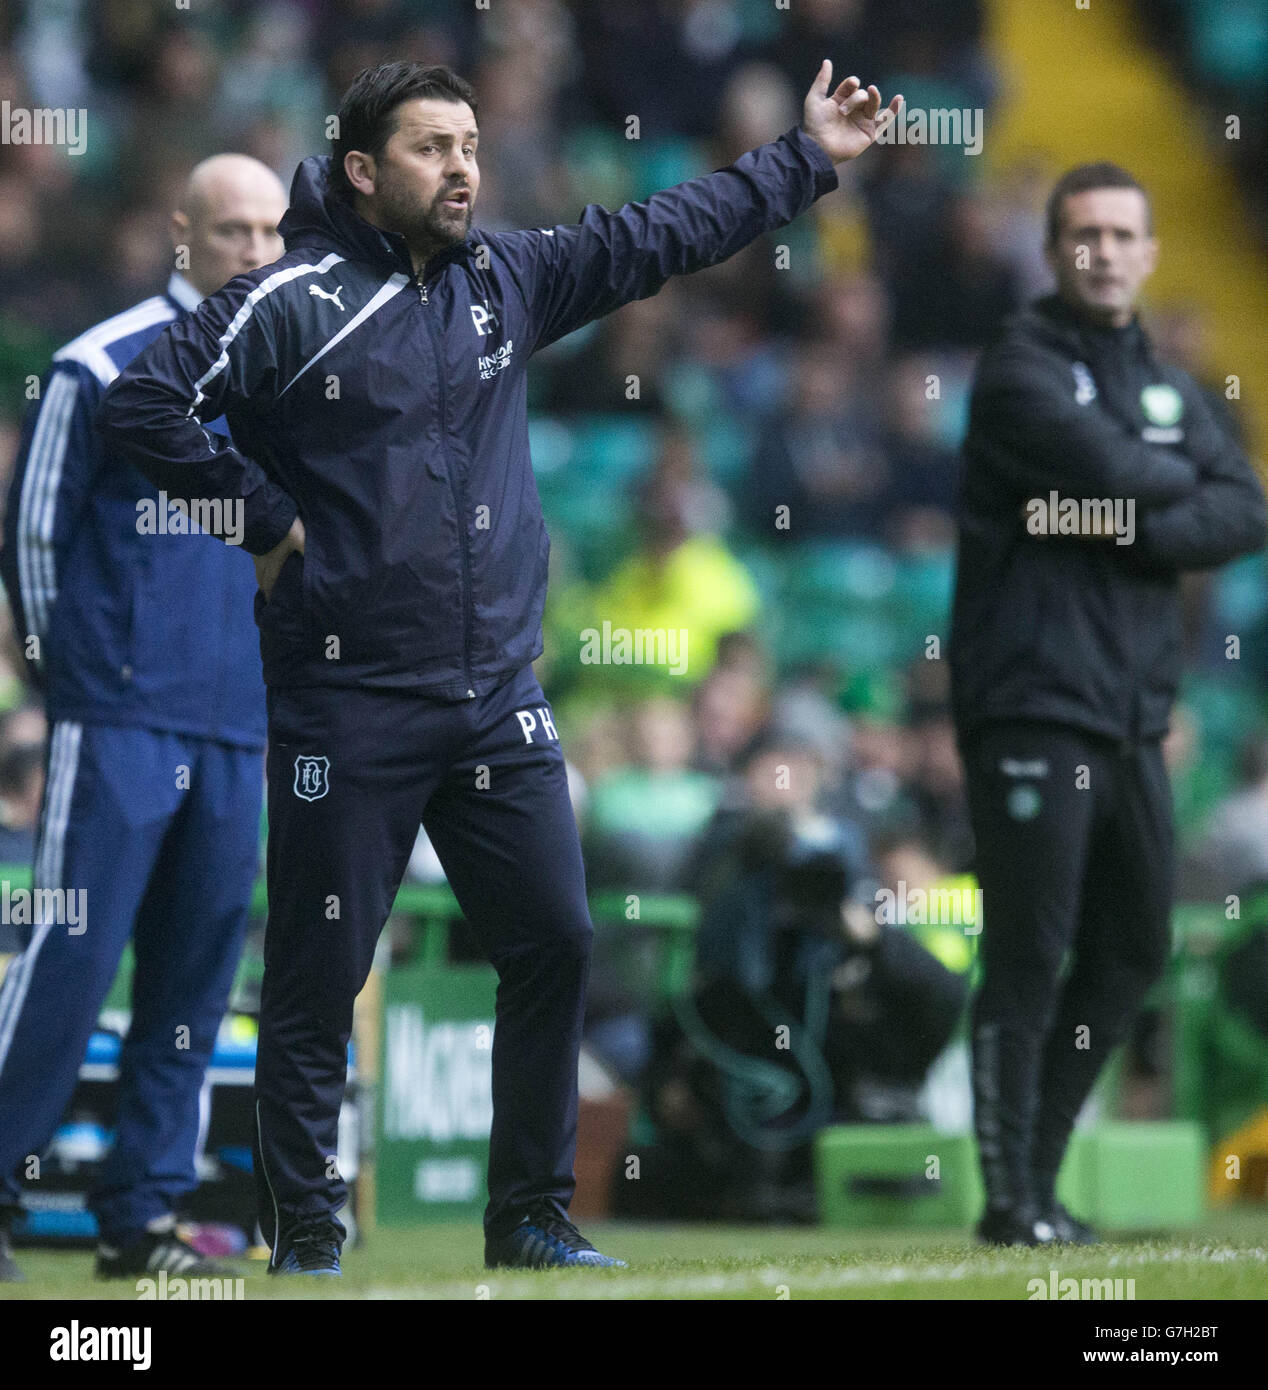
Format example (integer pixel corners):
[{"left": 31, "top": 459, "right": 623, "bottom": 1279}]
[{"left": 0, "top": 0, "right": 1268, "bottom": 1162}]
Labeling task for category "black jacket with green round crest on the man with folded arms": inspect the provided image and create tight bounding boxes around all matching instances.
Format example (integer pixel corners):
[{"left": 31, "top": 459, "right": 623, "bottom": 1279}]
[{"left": 950, "top": 296, "right": 1265, "bottom": 739}]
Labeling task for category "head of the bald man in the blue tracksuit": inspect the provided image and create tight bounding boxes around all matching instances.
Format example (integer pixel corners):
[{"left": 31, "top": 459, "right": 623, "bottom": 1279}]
[{"left": 172, "top": 173, "right": 286, "bottom": 295}]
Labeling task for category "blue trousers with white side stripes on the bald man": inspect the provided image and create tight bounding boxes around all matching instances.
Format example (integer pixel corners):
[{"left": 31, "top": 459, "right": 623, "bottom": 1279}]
[{"left": 0, "top": 720, "right": 264, "bottom": 1245}]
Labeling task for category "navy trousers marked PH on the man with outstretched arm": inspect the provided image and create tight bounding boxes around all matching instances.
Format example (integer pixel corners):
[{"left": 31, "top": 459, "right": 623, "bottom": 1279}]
[{"left": 256, "top": 666, "right": 594, "bottom": 1262}]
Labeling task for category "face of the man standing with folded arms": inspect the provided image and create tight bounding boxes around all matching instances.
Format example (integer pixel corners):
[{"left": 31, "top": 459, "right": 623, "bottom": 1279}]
[{"left": 1047, "top": 188, "right": 1158, "bottom": 328}]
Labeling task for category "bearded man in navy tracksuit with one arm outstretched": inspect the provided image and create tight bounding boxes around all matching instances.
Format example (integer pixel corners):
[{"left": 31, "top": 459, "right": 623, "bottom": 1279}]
[{"left": 101, "top": 63, "right": 897, "bottom": 1273}]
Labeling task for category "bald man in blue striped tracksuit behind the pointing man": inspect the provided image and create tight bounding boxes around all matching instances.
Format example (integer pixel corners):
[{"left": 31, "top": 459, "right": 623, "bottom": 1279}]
[{"left": 0, "top": 156, "right": 285, "bottom": 1279}]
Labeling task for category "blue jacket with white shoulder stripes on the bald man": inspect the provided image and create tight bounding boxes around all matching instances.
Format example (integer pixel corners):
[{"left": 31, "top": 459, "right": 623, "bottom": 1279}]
[{"left": 0, "top": 275, "right": 264, "bottom": 748}]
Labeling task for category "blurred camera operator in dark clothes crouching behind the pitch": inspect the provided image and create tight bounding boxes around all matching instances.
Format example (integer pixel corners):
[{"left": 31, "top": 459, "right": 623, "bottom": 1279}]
[{"left": 624, "top": 734, "right": 964, "bottom": 1219}]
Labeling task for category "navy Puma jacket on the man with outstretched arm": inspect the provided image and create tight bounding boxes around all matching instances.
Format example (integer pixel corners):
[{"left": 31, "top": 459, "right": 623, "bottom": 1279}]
[{"left": 99, "top": 126, "right": 837, "bottom": 699}]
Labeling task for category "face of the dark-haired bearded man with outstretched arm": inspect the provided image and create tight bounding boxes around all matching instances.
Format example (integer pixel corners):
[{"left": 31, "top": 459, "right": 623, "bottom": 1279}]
[{"left": 349, "top": 97, "right": 480, "bottom": 252}]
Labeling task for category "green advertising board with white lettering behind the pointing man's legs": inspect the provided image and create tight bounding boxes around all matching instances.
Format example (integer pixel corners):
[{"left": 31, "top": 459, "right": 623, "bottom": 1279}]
[{"left": 375, "top": 965, "right": 498, "bottom": 1226}]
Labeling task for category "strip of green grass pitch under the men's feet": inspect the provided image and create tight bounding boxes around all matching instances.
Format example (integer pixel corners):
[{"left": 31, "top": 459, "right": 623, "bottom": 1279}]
[{"left": 0, "top": 1209, "right": 1268, "bottom": 1301}]
